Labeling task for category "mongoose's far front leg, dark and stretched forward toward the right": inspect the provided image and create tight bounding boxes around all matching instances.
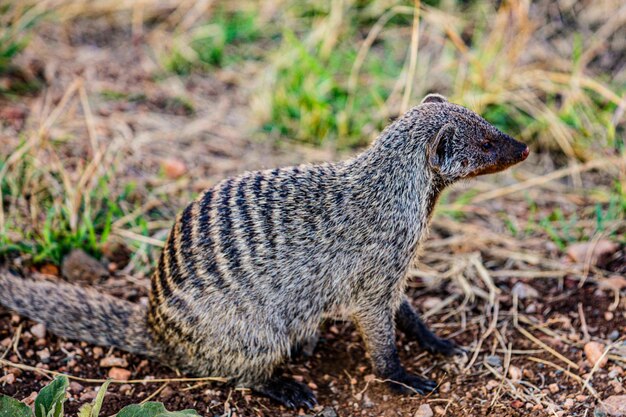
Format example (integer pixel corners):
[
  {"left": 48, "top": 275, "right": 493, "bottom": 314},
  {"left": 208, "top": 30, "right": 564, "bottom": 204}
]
[{"left": 396, "top": 298, "right": 462, "bottom": 356}]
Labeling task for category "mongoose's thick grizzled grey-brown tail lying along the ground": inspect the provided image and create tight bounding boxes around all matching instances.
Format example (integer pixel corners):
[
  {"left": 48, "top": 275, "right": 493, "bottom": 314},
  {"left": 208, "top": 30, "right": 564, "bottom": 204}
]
[{"left": 0, "top": 272, "right": 158, "bottom": 356}]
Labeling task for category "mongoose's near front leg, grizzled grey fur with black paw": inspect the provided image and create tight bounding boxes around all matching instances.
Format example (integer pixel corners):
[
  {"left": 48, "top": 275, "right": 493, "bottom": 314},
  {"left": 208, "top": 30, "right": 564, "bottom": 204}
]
[{"left": 355, "top": 308, "right": 437, "bottom": 395}]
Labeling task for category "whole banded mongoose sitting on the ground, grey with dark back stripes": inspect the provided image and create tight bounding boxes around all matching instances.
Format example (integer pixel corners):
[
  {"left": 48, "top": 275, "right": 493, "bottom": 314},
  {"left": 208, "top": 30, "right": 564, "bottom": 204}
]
[{"left": 0, "top": 94, "right": 529, "bottom": 407}]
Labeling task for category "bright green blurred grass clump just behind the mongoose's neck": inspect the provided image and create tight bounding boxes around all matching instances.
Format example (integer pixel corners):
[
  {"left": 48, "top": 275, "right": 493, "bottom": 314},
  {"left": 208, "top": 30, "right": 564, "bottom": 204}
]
[{"left": 263, "top": 31, "right": 401, "bottom": 148}]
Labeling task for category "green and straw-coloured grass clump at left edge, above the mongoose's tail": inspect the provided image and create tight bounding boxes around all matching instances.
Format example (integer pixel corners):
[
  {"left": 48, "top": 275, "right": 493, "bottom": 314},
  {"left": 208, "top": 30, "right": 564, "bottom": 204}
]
[{"left": 0, "top": 133, "right": 145, "bottom": 265}]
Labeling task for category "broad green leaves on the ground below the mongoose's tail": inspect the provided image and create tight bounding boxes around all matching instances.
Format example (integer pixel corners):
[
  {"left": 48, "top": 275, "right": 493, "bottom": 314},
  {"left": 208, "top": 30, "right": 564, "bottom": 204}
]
[{"left": 0, "top": 375, "right": 199, "bottom": 417}]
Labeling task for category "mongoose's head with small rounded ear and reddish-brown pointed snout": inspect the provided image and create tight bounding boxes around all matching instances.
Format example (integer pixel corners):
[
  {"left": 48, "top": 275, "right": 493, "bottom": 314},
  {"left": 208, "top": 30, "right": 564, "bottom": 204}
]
[{"left": 418, "top": 94, "right": 529, "bottom": 183}]
